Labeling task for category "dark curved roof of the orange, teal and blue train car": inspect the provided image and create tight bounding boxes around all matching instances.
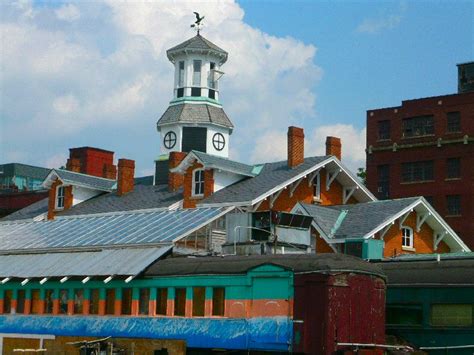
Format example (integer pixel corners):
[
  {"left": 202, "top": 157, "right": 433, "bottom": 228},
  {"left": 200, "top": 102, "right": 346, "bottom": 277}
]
[{"left": 144, "top": 254, "right": 385, "bottom": 277}]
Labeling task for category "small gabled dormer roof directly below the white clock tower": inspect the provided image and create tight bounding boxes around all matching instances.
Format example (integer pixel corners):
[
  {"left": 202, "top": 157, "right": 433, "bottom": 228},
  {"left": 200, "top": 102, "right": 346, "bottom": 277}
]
[{"left": 171, "top": 150, "right": 259, "bottom": 177}]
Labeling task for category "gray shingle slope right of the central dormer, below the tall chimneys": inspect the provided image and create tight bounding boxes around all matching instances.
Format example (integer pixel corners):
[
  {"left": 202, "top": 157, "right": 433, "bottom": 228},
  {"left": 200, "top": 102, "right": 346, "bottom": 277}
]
[{"left": 201, "top": 156, "right": 330, "bottom": 205}]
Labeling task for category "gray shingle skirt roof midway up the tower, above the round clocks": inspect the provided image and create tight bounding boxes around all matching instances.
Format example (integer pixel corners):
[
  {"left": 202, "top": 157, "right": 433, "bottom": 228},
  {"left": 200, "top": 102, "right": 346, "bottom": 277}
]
[{"left": 157, "top": 103, "right": 234, "bottom": 128}]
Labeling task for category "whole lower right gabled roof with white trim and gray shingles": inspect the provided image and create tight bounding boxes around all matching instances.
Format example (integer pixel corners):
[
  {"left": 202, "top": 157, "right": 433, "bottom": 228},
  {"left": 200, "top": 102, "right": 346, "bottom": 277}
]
[{"left": 293, "top": 197, "right": 469, "bottom": 251}]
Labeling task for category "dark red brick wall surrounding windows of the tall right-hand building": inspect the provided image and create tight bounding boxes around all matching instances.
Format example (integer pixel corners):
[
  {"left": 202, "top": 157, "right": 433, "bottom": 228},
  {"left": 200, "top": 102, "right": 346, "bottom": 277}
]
[{"left": 367, "top": 92, "right": 474, "bottom": 249}]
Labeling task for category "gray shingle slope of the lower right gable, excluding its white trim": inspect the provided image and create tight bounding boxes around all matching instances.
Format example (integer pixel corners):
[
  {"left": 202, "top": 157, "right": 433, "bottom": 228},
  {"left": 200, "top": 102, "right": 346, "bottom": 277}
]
[{"left": 301, "top": 197, "right": 420, "bottom": 238}]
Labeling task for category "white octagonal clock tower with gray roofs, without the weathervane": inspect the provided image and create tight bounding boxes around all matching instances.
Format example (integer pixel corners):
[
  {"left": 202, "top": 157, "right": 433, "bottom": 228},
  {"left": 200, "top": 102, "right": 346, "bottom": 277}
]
[{"left": 157, "top": 32, "right": 234, "bottom": 158}]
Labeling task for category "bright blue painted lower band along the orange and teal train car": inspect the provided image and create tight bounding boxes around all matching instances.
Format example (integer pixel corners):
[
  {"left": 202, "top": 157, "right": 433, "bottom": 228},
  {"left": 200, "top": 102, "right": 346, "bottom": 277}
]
[{"left": 0, "top": 315, "right": 293, "bottom": 351}]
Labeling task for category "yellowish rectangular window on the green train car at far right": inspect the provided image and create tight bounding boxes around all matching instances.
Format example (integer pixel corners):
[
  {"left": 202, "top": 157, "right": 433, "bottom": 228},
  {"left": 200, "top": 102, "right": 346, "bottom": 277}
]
[{"left": 431, "top": 304, "right": 474, "bottom": 327}]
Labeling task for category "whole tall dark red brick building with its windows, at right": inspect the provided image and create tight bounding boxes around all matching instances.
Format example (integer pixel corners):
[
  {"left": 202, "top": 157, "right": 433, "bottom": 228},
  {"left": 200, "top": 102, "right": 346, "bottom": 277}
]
[{"left": 367, "top": 62, "right": 474, "bottom": 248}]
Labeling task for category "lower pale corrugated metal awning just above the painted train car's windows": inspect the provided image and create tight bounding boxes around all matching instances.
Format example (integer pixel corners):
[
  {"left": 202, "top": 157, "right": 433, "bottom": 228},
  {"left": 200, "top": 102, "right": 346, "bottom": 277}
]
[{"left": 0, "top": 246, "right": 172, "bottom": 278}]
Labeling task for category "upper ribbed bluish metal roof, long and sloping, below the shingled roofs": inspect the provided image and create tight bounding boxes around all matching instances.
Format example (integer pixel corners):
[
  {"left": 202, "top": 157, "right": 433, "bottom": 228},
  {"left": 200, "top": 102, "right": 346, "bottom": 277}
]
[{"left": 0, "top": 207, "right": 233, "bottom": 254}]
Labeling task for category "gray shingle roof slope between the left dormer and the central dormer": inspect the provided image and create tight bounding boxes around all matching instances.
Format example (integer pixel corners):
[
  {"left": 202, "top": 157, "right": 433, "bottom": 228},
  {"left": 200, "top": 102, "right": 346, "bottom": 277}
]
[{"left": 58, "top": 185, "right": 183, "bottom": 216}]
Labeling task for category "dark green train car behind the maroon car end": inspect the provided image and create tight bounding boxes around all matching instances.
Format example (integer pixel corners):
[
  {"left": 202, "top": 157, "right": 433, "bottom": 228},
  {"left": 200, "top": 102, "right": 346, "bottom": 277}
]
[{"left": 379, "top": 253, "right": 474, "bottom": 355}]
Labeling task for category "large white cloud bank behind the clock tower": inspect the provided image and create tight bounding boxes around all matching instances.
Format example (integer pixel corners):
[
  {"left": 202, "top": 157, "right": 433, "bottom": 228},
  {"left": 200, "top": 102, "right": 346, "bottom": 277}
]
[{"left": 0, "top": 1, "right": 322, "bottom": 171}]
